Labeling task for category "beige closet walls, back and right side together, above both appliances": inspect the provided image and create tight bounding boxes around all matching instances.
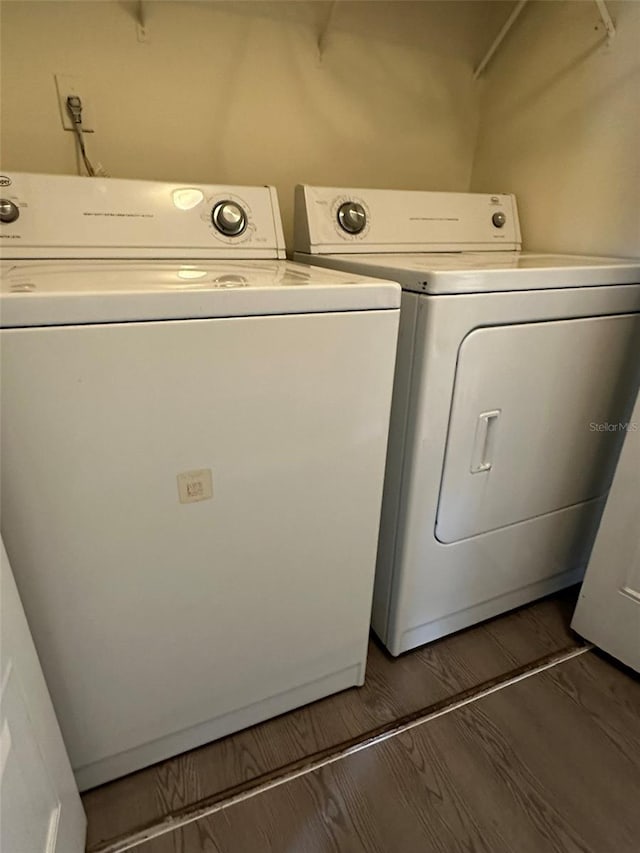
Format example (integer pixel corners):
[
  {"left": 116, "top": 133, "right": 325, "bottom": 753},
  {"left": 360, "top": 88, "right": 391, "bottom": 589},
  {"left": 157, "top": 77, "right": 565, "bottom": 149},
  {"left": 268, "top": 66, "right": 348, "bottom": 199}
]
[{"left": 0, "top": 0, "right": 640, "bottom": 255}]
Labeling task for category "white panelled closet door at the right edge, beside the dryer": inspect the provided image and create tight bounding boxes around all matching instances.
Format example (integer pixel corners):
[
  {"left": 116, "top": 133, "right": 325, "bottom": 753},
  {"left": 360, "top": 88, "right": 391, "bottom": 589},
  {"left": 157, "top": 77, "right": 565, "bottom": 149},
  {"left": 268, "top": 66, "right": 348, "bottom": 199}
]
[{"left": 571, "top": 386, "right": 640, "bottom": 673}]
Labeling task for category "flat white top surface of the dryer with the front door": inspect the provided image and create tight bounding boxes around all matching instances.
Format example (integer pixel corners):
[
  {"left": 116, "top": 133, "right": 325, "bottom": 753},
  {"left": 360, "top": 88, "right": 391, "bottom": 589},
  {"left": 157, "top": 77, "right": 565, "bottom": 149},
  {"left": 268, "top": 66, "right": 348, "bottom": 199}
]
[{"left": 306, "top": 252, "right": 640, "bottom": 294}]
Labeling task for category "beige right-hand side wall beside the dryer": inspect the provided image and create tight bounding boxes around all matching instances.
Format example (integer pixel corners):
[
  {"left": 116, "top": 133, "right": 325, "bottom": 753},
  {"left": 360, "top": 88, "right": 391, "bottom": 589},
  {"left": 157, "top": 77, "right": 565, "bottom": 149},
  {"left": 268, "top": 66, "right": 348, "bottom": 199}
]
[{"left": 471, "top": 2, "right": 640, "bottom": 256}]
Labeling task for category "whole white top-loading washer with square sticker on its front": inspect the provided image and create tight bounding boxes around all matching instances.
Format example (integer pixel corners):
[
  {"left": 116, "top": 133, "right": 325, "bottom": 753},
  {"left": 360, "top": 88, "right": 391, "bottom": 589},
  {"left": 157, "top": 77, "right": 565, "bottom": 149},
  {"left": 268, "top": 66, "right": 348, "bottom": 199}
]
[{"left": 0, "top": 174, "right": 400, "bottom": 788}]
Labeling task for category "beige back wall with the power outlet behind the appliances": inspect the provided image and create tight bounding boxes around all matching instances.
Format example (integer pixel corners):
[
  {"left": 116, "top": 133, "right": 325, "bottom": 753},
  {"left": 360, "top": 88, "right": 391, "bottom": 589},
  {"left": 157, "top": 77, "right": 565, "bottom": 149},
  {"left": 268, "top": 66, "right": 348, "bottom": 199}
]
[{"left": 0, "top": 0, "right": 500, "bottom": 244}]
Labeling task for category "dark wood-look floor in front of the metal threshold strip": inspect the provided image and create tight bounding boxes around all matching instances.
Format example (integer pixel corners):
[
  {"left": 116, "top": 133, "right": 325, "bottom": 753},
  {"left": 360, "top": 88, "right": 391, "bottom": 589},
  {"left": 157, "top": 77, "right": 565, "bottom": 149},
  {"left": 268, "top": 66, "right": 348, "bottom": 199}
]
[{"left": 134, "top": 652, "right": 640, "bottom": 853}]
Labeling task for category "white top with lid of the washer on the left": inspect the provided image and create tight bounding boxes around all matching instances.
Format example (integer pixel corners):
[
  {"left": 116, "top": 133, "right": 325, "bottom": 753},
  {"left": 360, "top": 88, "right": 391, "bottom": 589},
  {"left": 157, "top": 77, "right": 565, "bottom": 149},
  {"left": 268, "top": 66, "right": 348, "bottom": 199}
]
[{"left": 0, "top": 261, "right": 400, "bottom": 327}]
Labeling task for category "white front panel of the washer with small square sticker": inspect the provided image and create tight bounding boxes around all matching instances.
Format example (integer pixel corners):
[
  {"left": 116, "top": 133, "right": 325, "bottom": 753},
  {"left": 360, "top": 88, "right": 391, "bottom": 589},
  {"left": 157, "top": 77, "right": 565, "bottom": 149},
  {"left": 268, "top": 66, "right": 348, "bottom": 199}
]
[{"left": 0, "top": 311, "right": 399, "bottom": 784}]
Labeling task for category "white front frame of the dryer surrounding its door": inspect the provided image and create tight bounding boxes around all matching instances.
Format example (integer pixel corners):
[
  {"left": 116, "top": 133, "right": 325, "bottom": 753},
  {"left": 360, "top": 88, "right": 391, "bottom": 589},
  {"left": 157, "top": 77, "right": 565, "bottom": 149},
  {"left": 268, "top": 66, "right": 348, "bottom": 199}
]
[{"left": 373, "top": 286, "right": 639, "bottom": 654}]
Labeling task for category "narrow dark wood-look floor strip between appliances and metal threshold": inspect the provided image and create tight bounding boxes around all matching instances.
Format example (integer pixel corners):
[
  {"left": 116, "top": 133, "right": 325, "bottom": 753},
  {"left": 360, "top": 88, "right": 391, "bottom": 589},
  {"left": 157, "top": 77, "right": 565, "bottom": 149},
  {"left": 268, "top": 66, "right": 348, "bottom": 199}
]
[{"left": 83, "top": 588, "right": 580, "bottom": 853}]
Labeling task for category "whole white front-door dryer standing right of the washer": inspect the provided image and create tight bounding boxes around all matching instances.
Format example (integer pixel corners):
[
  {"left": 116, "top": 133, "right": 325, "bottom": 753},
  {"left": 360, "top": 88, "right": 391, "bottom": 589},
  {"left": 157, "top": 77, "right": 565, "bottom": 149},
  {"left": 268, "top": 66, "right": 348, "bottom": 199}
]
[{"left": 294, "top": 186, "right": 640, "bottom": 654}]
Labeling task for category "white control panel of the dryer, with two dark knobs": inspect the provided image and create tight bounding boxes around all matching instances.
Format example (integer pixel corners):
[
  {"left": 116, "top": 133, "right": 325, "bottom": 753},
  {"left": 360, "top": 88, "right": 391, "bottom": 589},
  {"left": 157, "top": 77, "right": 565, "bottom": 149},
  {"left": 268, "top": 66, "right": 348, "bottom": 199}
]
[{"left": 295, "top": 185, "right": 521, "bottom": 254}]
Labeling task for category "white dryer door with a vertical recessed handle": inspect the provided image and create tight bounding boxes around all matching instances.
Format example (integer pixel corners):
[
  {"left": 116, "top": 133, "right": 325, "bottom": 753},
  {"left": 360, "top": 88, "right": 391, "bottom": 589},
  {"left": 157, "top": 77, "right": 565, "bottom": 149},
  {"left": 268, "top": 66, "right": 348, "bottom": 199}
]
[{"left": 436, "top": 314, "right": 640, "bottom": 543}]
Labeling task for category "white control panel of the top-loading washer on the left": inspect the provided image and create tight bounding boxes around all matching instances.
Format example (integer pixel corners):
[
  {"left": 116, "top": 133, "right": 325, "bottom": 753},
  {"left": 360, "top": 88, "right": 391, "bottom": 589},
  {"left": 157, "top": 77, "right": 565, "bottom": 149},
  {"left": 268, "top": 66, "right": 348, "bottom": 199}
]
[{"left": 0, "top": 173, "right": 285, "bottom": 259}]
